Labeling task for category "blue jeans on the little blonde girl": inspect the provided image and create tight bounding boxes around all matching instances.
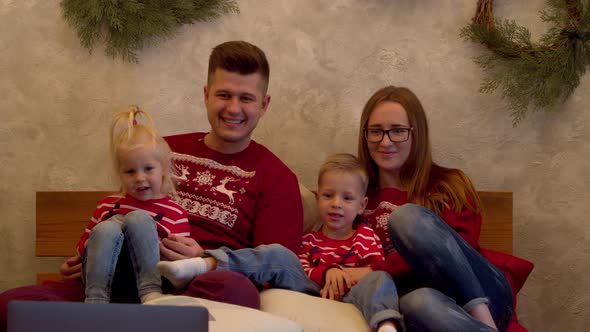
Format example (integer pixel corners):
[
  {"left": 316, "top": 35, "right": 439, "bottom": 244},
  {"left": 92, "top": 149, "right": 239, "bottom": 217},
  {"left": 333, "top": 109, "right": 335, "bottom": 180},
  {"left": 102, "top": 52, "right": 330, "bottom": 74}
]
[{"left": 82, "top": 210, "right": 161, "bottom": 303}]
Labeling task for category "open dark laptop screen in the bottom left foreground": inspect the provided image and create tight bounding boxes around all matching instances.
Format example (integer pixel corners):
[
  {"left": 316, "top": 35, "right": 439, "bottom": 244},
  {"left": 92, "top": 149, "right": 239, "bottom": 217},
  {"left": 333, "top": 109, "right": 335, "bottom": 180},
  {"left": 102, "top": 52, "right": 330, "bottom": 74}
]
[{"left": 8, "top": 301, "right": 209, "bottom": 332}]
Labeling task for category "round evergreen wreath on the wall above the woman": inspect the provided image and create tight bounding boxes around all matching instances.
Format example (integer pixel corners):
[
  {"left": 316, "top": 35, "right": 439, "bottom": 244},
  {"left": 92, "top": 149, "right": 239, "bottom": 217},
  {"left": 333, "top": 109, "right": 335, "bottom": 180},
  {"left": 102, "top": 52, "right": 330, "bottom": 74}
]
[{"left": 461, "top": 0, "right": 590, "bottom": 126}]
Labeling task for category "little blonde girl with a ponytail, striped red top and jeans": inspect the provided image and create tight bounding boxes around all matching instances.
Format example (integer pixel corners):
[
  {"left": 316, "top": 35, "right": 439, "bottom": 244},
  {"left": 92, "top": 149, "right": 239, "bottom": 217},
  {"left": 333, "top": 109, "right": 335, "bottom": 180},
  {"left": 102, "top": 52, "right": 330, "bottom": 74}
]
[{"left": 77, "top": 106, "right": 189, "bottom": 303}]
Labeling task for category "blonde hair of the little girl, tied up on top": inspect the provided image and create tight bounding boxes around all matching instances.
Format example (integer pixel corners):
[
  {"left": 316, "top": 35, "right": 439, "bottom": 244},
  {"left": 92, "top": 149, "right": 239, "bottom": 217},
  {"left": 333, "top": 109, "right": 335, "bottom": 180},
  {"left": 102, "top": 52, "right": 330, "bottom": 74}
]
[{"left": 111, "top": 105, "right": 176, "bottom": 197}]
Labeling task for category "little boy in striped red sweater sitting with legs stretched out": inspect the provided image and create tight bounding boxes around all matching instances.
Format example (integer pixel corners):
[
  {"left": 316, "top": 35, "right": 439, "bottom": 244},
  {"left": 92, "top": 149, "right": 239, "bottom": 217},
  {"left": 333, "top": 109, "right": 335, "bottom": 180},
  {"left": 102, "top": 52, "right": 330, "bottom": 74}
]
[{"left": 157, "top": 154, "right": 401, "bottom": 332}]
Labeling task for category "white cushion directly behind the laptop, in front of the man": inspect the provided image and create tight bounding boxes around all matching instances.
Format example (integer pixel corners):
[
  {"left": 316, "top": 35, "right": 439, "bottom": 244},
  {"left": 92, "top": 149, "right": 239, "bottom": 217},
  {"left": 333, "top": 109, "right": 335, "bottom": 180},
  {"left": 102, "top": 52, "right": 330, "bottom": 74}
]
[{"left": 146, "top": 296, "right": 303, "bottom": 332}]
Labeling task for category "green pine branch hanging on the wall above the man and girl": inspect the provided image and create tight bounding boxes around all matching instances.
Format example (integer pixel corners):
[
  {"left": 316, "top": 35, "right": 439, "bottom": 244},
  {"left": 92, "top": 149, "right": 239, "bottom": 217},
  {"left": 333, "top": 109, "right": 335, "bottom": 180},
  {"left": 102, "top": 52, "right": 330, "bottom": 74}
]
[{"left": 61, "top": 0, "right": 239, "bottom": 62}]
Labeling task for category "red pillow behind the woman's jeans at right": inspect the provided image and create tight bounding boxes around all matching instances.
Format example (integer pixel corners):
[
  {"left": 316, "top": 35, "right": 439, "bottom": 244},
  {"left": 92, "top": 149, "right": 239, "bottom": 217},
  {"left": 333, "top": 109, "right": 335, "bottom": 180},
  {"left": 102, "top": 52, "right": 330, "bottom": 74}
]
[{"left": 480, "top": 248, "right": 535, "bottom": 296}]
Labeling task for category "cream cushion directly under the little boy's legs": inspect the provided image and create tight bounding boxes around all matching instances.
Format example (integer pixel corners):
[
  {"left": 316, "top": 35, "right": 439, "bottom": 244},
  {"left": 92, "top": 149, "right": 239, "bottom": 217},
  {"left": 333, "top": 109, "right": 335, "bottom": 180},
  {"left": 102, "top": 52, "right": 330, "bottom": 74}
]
[{"left": 260, "top": 289, "right": 371, "bottom": 332}]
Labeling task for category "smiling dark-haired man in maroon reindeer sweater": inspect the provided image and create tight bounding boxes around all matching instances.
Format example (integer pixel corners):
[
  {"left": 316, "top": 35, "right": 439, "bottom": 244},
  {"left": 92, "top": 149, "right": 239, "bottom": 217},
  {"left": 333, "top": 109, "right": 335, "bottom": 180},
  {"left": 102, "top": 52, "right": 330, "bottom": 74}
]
[{"left": 0, "top": 41, "right": 303, "bottom": 330}]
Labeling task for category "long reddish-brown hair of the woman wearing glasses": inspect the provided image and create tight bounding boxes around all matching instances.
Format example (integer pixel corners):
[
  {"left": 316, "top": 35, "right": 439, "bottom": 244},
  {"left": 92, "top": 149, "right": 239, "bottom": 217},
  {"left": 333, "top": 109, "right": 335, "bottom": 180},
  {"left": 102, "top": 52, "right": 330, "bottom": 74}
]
[{"left": 358, "top": 86, "right": 482, "bottom": 214}]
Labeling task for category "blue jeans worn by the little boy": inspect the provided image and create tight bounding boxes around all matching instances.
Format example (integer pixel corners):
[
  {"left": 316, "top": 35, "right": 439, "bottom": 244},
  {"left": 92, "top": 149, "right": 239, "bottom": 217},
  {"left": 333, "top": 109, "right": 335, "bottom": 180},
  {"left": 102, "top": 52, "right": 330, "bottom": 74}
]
[{"left": 204, "top": 244, "right": 401, "bottom": 327}]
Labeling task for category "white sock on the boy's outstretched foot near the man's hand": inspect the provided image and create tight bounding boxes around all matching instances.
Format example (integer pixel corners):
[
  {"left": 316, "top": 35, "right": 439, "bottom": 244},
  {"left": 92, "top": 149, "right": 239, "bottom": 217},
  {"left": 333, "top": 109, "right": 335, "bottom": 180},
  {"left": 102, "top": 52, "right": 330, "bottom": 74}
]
[{"left": 156, "top": 257, "right": 209, "bottom": 288}]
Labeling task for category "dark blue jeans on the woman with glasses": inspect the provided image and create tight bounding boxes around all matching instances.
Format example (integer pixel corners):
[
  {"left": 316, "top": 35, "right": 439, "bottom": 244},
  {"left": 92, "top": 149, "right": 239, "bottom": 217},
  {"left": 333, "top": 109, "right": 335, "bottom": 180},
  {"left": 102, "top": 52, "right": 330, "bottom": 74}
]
[{"left": 389, "top": 204, "right": 514, "bottom": 331}]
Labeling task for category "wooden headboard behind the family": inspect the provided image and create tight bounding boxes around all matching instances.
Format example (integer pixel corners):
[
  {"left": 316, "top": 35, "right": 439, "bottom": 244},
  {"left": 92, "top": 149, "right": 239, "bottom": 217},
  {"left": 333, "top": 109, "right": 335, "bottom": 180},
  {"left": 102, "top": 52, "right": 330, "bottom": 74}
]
[{"left": 35, "top": 191, "right": 512, "bottom": 282}]
